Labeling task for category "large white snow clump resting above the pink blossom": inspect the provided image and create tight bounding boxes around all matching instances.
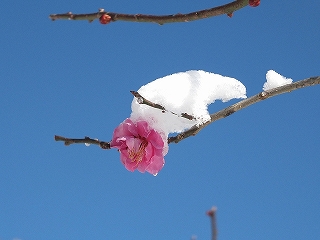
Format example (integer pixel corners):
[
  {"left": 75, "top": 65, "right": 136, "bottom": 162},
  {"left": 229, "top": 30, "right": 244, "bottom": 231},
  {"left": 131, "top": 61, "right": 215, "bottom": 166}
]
[{"left": 130, "top": 70, "right": 247, "bottom": 135}]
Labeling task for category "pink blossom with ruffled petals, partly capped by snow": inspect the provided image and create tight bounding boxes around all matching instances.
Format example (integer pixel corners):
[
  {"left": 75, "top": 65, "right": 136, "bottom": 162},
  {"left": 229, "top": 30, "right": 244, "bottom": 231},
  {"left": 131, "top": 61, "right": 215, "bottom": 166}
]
[{"left": 110, "top": 118, "right": 165, "bottom": 175}]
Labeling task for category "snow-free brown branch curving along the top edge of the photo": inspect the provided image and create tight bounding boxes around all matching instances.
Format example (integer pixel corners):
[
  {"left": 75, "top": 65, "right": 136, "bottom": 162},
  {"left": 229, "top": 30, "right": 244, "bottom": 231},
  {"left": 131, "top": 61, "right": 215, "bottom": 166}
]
[{"left": 49, "top": 0, "right": 249, "bottom": 25}]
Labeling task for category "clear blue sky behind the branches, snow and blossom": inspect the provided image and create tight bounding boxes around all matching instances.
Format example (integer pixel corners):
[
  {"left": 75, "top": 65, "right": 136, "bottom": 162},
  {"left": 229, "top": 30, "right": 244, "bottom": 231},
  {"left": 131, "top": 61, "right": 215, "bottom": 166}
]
[{"left": 0, "top": 0, "right": 320, "bottom": 240}]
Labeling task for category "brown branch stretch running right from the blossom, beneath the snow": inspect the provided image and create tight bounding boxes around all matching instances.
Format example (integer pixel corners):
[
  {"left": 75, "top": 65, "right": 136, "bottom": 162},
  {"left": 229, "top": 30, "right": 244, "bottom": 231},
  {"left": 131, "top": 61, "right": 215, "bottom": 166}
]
[{"left": 168, "top": 77, "right": 320, "bottom": 143}]
